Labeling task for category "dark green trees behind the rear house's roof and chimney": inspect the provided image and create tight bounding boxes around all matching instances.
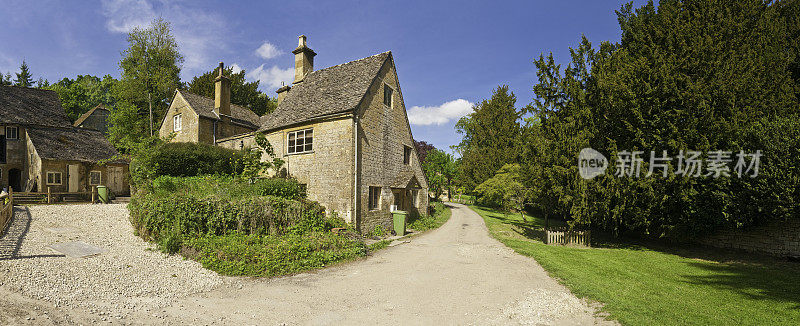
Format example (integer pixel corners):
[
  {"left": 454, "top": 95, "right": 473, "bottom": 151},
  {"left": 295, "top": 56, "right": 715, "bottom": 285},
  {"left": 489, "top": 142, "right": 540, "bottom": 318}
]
[{"left": 183, "top": 66, "right": 278, "bottom": 116}]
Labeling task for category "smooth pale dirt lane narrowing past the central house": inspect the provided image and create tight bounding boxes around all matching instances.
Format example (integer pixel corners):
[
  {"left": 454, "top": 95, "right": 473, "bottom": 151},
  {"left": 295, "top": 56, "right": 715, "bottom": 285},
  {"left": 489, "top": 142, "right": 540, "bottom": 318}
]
[{"left": 139, "top": 205, "right": 613, "bottom": 325}]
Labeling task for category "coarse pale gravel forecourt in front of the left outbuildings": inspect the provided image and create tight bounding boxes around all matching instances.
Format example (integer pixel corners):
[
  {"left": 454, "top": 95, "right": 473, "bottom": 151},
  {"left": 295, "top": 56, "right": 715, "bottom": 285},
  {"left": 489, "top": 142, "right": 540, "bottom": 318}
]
[{"left": 0, "top": 204, "right": 224, "bottom": 320}]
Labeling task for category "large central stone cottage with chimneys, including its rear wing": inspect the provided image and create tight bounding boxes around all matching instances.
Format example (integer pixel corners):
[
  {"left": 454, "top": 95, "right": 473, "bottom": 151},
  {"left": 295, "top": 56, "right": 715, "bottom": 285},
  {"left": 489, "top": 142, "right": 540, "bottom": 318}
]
[{"left": 162, "top": 36, "right": 428, "bottom": 232}]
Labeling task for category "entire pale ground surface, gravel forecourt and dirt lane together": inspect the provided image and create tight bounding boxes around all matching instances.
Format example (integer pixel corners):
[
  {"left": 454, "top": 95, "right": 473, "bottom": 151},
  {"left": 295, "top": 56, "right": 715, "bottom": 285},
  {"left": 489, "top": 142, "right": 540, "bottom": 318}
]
[{"left": 0, "top": 205, "right": 614, "bottom": 325}]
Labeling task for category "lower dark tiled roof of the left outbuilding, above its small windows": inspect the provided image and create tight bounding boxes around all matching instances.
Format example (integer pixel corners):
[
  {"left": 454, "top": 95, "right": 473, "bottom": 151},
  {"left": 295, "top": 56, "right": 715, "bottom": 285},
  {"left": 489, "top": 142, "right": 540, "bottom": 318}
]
[{"left": 27, "top": 127, "right": 124, "bottom": 163}]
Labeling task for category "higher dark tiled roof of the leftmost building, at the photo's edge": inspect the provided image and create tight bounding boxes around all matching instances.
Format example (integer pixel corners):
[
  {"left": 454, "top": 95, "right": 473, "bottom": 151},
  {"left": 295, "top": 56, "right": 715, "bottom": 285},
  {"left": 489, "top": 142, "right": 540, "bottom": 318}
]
[{"left": 0, "top": 86, "right": 72, "bottom": 127}]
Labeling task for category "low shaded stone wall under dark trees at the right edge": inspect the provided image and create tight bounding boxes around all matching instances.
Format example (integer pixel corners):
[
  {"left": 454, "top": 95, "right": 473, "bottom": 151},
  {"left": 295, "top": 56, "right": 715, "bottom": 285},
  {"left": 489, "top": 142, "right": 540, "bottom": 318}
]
[{"left": 699, "top": 218, "right": 800, "bottom": 258}]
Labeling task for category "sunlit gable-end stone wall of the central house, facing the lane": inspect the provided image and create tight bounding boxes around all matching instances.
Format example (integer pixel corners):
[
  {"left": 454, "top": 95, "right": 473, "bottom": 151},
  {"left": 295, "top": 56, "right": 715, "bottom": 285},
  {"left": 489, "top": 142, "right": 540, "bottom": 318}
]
[{"left": 358, "top": 57, "right": 428, "bottom": 232}]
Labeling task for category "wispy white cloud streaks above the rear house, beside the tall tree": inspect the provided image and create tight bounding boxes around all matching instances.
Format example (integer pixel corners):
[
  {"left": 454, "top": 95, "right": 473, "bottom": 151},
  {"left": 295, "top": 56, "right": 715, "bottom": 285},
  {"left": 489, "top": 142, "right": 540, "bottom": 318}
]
[{"left": 102, "top": 0, "right": 227, "bottom": 73}]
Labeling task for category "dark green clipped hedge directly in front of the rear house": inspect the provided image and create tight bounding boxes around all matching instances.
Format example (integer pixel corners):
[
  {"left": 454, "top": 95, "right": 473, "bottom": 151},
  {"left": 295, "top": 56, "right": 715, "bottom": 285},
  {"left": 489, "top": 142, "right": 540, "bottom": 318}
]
[{"left": 131, "top": 143, "right": 244, "bottom": 185}]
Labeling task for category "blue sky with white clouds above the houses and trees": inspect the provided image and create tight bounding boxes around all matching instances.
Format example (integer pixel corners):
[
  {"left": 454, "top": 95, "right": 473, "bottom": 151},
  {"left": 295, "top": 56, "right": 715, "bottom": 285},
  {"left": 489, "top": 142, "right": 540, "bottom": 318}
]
[{"left": 0, "top": 0, "right": 643, "bottom": 149}]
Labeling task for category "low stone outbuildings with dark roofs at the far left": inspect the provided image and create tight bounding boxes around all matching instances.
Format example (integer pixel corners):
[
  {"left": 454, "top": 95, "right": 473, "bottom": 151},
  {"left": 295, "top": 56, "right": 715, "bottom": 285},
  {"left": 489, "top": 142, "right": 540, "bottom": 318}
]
[{"left": 0, "top": 86, "right": 130, "bottom": 195}]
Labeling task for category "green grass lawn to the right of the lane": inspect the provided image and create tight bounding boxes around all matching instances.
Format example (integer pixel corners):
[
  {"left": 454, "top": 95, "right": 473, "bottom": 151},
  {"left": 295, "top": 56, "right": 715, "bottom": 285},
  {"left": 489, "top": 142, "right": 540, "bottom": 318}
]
[{"left": 470, "top": 206, "right": 800, "bottom": 325}]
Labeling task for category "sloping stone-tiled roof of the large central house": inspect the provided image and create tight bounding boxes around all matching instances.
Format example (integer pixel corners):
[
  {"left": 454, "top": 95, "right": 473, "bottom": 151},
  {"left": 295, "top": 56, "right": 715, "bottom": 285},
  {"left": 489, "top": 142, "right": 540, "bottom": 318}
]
[{"left": 260, "top": 51, "right": 392, "bottom": 131}]
